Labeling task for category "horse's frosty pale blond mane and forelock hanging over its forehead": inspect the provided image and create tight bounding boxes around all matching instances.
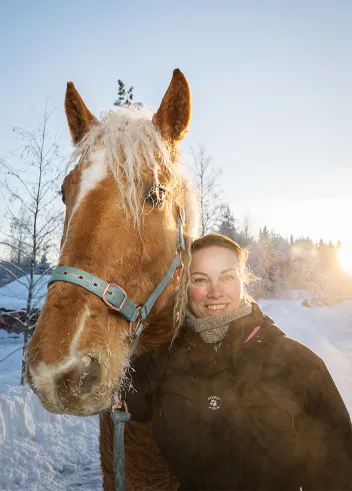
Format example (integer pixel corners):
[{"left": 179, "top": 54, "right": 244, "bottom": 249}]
[{"left": 72, "top": 106, "right": 198, "bottom": 330}]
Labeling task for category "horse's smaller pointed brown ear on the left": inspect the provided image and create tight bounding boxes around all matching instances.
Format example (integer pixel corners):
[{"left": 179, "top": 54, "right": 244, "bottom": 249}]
[{"left": 65, "top": 82, "right": 98, "bottom": 145}]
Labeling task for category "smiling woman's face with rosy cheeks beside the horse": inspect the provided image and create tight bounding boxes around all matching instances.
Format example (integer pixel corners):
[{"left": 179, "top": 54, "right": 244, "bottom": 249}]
[{"left": 188, "top": 246, "right": 242, "bottom": 317}]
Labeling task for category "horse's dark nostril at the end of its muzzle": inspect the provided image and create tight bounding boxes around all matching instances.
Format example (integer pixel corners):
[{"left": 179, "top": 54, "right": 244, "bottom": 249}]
[{"left": 56, "top": 356, "right": 101, "bottom": 405}]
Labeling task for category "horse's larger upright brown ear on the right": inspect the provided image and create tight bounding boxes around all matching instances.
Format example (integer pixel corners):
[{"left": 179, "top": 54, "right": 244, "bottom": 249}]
[{"left": 153, "top": 68, "right": 192, "bottom": 141}]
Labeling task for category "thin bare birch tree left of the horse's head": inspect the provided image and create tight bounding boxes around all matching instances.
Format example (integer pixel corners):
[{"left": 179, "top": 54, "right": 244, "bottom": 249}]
[{"left": 0, "top": 106, "right": 63, "bottom": 383}]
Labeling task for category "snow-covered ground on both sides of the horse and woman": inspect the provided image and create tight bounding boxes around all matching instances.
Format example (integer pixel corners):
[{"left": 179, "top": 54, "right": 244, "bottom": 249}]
[{"left": 0, "top": 300, "right": 352, "bottom": 491}]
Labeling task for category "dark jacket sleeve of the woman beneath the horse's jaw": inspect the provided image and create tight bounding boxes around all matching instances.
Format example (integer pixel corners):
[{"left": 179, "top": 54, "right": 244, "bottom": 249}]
[{"left": 122, "top": 349, "right": 165, "bottom": 421}]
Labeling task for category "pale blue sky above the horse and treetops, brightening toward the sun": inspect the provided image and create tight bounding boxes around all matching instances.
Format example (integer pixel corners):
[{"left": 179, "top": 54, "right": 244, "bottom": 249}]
[{"left": 0, "top": 0, "right": 352, "bottom": 245}]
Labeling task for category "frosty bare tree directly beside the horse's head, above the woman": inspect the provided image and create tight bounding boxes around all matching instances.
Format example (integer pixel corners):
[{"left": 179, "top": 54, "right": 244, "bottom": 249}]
[{"left": 191, "top": 146, "right": 225, "bottom": 236}]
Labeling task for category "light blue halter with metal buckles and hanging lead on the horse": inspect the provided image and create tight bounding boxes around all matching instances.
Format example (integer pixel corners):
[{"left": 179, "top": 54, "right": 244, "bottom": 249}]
[{"left": 48, "top": 208, "right": 185, "bottom": 491}]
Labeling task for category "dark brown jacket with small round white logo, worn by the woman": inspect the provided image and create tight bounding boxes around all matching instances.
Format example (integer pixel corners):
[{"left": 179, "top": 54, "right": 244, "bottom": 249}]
[{"left": 126, "top": 303, "right": 352, "bottom": 491}]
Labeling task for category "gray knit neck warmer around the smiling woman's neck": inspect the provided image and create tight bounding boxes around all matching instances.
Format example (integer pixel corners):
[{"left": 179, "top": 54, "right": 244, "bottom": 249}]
[{"left": 185, "top": 298, "right": 252, "bottom": 343}]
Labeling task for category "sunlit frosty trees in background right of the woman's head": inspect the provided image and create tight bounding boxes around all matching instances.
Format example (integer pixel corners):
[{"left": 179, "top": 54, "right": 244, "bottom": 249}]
[{"left": 218, "top": 205, "right": 352, "bottom": 306}]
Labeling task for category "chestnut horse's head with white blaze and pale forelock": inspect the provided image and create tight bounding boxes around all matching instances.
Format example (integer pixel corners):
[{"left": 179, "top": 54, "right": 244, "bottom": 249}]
[{"left": 27, "top": 70, "right": 195, "bottom": 415}]
